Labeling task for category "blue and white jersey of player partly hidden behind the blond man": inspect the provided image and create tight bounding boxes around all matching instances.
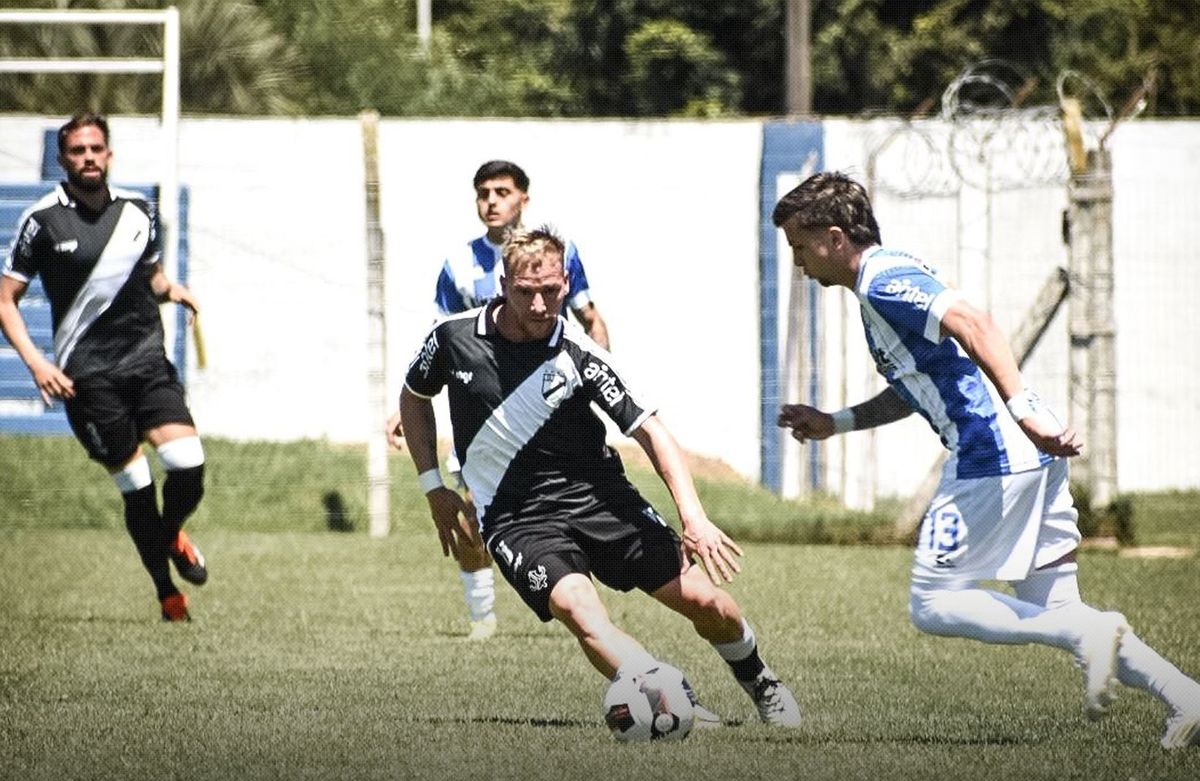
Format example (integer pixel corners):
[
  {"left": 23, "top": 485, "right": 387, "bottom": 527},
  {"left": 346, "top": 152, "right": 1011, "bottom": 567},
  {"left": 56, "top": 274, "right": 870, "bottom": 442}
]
[{"left": 433, "top": 235, "right": 592, "bottom": 316}]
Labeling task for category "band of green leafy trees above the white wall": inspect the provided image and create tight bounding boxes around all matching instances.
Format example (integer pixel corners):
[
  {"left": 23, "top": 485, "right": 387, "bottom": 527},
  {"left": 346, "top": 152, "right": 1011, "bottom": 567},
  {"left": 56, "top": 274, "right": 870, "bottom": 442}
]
[{"left": 0, "top": 0, "right": 1200, "bottom": 116}]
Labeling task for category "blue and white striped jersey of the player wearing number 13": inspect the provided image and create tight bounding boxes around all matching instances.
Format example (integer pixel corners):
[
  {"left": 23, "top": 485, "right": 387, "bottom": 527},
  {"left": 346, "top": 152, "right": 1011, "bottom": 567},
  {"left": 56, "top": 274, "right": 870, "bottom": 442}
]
[{"left": 854, "top": 247, "right": 1054, "bottom": 479}]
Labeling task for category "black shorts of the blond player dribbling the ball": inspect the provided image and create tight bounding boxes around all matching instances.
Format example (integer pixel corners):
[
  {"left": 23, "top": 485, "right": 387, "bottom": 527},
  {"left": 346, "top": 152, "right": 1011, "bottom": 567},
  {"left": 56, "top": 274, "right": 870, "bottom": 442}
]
[{"left": 486, "top": 486, "right": 683, "bottom": 621}]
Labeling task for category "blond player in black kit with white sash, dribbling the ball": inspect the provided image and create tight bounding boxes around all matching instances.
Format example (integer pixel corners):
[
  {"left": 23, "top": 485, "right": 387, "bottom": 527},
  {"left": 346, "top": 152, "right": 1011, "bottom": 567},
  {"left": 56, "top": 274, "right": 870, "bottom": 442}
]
[{"left": 400, "top": 229, "right": 800, "bottom": 727}]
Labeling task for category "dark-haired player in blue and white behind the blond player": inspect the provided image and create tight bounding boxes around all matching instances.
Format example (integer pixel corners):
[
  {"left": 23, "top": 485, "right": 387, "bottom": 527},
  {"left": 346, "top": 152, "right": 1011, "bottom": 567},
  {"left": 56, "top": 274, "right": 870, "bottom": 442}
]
[{"left": 388, "top": 160, "right": 608, "bottom": 639}]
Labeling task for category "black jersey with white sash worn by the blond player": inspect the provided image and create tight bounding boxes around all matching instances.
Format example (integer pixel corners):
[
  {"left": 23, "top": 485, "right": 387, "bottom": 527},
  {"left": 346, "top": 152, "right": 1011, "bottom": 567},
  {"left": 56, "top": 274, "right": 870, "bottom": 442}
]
[{"left": 404, "top": 300, "right": 654, "bottom": 524}]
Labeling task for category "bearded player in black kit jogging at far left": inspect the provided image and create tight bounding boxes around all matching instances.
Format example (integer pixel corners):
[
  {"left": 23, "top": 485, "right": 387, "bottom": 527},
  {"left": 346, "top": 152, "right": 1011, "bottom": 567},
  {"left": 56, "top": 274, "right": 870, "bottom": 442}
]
[{"left": 0, "top": 113, "right": 208, "bottom": 621}]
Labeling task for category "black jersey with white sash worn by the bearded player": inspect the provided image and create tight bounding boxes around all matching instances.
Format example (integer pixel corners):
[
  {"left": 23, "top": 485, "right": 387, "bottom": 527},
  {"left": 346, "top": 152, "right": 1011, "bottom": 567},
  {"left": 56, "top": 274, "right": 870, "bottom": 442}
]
[{"left": 4, "top": 185, "right": 163, "bottom": 377}]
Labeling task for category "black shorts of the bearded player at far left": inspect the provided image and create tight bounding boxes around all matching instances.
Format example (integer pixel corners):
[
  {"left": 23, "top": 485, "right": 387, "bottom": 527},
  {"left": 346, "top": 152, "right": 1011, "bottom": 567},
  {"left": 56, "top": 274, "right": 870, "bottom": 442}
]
[{"left": 64, "top": 355, "right": 196, "bottom": 468}]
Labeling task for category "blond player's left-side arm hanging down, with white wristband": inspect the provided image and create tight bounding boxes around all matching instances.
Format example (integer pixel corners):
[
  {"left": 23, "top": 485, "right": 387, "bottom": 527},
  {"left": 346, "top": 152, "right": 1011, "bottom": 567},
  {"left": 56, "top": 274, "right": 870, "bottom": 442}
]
[{"left": 400, "top": 388, "right": 478, "bottom": 559}]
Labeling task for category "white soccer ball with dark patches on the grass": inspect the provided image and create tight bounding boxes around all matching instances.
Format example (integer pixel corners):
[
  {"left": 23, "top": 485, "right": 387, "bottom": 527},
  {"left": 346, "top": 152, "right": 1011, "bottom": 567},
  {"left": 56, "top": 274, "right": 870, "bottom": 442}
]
[{"left": 604, "top": 662, "right": 695, "bottom": 743}]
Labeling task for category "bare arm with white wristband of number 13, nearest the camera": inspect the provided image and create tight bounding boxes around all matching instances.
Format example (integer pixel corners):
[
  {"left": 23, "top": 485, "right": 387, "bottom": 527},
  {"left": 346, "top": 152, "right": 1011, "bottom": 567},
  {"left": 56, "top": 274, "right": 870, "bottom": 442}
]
[{"left": 942, "top": 301, "right": 1084, "bottom": 457}]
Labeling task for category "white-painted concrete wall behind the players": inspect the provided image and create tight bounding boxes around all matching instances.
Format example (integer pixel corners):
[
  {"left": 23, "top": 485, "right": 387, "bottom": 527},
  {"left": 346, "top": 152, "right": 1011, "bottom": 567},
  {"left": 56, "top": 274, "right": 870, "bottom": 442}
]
[{"left": 0, "top": 116, "right": 1200, "bottom": 494}]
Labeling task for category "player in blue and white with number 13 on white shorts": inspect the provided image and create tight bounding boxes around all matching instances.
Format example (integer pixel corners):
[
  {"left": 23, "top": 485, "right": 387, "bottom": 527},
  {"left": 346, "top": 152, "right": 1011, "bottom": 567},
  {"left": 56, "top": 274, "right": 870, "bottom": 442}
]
[{"left": 774, "top": 173, "right": 1200, "bottom": 749}]
